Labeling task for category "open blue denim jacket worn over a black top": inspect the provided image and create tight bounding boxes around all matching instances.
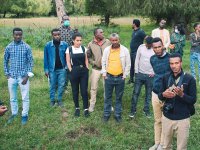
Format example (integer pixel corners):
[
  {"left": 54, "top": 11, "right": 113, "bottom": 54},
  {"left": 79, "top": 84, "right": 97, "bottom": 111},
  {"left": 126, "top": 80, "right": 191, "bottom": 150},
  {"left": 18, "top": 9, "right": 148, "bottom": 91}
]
[{"left": 44, "top": 41, "right": 68, "bottom": 73}]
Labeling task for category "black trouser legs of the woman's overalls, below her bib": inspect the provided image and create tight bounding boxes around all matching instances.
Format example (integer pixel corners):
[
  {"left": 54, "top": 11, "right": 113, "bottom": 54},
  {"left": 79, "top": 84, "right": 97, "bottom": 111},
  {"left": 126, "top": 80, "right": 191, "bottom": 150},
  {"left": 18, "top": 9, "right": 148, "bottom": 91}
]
[{"left": 69, "top": 67, "right": 88, "bottom": 109}]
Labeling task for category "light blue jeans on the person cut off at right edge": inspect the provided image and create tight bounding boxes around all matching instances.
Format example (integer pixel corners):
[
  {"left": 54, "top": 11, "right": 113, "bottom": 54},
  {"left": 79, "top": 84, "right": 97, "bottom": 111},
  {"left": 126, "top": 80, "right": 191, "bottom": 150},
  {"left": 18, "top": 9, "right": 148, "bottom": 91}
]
[{"left": 190, "top": 52, "right": 200, "bottom": 80}]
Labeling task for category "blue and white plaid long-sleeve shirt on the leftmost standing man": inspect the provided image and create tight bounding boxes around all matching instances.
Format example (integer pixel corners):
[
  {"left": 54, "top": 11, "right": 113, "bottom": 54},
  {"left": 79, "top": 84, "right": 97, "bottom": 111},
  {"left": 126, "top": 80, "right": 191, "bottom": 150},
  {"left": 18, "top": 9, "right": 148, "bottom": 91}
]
[{"left": 4, "top": 41, "right": 33, "bottom": 79}]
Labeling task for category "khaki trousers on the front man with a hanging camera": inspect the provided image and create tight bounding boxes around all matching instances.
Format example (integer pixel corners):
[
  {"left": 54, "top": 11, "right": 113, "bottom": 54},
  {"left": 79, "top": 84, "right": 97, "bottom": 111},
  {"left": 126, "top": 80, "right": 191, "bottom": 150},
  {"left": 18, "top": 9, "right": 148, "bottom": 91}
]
[{"left": 162, "top": 115, "right": 190, "bottom": 150}]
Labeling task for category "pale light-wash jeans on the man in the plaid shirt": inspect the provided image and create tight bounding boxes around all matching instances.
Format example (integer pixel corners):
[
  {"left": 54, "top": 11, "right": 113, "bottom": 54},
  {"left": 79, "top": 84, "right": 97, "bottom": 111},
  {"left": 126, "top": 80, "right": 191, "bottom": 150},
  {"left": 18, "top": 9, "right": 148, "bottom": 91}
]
[{"left": 8, "top": 77, "right": 30, "bottom": 116}]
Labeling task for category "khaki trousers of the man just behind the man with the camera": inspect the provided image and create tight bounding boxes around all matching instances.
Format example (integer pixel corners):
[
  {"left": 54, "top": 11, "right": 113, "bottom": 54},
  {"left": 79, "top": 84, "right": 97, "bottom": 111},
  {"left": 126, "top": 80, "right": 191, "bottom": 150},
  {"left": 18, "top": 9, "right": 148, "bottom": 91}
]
[{"left": 152, "top": 92, "right": 163, "bottom": 145}]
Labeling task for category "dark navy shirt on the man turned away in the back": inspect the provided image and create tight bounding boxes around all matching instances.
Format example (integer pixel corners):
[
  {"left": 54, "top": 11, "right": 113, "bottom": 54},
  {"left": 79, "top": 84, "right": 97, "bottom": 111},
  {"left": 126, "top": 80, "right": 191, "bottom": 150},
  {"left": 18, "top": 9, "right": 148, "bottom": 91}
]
[{"left": 130, "top": 28, "right": 146, "bottom": 55}]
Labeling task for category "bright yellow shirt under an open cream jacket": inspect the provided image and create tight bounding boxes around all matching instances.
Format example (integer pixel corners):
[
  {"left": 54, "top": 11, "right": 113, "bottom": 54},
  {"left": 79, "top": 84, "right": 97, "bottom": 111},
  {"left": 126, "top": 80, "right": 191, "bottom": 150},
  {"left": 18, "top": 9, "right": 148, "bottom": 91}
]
[{"left": 107, "top": 48, "right": 123, "bottom": 75}]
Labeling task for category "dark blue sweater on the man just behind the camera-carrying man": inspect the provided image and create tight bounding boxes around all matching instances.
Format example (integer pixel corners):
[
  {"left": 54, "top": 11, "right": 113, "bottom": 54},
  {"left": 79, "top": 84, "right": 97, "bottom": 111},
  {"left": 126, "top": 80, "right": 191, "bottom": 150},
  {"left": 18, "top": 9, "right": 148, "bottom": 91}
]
[{"left": 150, "top": 53, "right": 171, "bottom": 94}]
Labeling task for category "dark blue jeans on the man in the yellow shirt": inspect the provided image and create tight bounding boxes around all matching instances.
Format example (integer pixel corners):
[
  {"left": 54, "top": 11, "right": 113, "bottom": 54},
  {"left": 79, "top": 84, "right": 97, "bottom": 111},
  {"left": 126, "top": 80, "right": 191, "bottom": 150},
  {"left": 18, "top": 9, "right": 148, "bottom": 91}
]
[{"left": 104, "top": 75, "right": 124, "bottom": 116}]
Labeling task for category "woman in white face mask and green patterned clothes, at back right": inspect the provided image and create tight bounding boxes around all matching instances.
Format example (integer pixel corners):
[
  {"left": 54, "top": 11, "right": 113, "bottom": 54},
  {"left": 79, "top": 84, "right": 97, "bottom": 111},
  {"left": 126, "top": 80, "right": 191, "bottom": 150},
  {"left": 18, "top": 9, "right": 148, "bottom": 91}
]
[{"left": 169, "top": 24, "right": 185, "bottom": 56}]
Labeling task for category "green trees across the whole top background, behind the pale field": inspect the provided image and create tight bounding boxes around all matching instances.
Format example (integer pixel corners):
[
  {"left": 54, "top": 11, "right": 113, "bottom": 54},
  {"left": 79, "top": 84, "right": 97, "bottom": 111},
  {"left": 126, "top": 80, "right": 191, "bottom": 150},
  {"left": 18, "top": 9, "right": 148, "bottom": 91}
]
[{"left": 0, "top": 0, "right": 200, "bottom": 25}]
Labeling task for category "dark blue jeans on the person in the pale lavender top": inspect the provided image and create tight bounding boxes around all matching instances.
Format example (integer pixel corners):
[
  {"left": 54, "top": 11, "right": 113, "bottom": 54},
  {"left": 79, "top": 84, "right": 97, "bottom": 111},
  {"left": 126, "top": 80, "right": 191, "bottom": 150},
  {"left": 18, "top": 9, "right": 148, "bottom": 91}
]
[{"left": 131, "top": 73, "right": 153, "bottom": 113}]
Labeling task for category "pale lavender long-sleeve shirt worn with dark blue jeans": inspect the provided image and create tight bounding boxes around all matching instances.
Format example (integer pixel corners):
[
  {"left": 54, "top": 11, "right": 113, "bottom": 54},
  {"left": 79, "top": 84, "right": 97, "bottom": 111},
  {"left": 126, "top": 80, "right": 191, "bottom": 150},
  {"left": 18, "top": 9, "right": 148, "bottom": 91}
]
[{"left": 135, "top": 44, "right": 155, "bottom": 74}]
